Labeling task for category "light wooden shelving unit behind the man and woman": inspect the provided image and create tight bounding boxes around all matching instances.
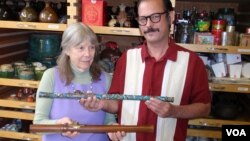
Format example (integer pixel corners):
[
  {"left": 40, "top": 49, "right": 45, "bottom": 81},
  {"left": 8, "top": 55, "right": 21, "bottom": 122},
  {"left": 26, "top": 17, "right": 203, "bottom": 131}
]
[{"left": 0, "top": 0, "right": 250, "bottom": 141}]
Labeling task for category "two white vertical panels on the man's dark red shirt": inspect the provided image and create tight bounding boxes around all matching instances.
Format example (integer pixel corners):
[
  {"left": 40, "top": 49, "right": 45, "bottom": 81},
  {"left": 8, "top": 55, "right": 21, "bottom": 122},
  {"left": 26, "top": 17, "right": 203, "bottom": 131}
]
[{"left": 121, "top": 48, "right": 189, "bottom": 141}]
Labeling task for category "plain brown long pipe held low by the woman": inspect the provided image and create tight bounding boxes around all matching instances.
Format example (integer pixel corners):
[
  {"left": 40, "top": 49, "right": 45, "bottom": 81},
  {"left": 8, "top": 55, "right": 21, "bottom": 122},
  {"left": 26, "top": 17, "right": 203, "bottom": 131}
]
[{"left": 30, "top": 124, "right": 154, "bottom": 133}]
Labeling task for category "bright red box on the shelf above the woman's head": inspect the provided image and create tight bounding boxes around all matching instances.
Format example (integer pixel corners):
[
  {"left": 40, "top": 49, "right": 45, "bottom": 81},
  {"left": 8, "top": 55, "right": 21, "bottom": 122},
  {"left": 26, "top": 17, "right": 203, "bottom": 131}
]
[{"left": 82, "top": 0, "right": 106, "bottom": 26}]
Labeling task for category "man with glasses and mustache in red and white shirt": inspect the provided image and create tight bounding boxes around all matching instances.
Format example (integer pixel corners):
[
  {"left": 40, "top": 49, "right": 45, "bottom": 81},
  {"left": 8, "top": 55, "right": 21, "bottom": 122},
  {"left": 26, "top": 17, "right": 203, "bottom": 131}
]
[{"left": 80, "top": 0, "right": 211, "bottom": 141}]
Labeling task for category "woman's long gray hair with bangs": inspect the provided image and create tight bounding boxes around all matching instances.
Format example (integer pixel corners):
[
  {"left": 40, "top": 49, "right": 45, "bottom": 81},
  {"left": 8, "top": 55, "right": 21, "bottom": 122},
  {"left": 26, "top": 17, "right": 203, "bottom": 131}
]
[{"left": 57, "top": 22, "right": 100, "bottom": 85}]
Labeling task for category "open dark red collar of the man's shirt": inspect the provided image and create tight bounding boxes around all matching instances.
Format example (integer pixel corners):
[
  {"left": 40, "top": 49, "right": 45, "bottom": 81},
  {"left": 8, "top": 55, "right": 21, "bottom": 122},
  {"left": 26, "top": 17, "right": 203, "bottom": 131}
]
[{"left": 141, "top": 39, "right": 178, "bottom": 62}]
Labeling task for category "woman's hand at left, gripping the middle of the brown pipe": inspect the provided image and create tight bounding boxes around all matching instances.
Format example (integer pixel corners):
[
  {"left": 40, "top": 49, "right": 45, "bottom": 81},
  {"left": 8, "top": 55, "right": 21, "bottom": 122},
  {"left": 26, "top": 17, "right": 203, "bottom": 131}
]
[{"left": 56, "top": 117, "right": 79, "bottom": 138}]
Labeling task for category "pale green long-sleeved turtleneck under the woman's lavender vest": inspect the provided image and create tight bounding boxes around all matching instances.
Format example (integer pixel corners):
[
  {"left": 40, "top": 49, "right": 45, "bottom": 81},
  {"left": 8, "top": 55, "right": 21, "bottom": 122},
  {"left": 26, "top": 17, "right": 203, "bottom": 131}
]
[{"left": 33, "top": 68, "right": 115, "bottom": 124}]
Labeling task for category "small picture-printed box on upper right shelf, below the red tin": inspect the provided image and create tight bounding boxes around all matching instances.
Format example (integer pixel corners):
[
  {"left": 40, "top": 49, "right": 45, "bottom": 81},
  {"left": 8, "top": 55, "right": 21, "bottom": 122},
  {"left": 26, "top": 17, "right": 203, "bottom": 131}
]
[{"left": 194, "top": 32, "right": 214, "bottom": 45}]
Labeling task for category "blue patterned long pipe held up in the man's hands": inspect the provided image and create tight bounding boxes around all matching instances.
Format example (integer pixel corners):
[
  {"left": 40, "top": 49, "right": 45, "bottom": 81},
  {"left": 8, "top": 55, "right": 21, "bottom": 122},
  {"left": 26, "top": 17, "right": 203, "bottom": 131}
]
[{"left": 39, "top": 90, "right": 174, "bottom": 102}]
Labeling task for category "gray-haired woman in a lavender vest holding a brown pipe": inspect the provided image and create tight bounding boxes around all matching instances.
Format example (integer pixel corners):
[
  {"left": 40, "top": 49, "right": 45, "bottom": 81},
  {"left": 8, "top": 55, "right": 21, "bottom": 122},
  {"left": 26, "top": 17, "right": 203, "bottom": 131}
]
[{"left": 34, "top": 23, "right": 114, "bottom": 141}]
